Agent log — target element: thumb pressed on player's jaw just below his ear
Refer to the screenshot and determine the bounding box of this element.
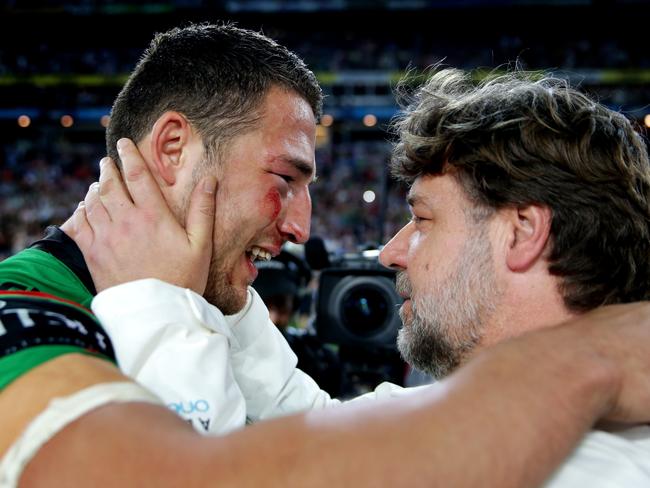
[185,175,217,252]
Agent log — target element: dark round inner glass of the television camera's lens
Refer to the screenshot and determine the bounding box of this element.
[341,285,389,336]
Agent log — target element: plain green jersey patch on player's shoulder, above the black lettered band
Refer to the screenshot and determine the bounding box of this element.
[0,249,93,309]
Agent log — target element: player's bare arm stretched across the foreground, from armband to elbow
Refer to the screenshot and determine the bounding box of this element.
[20,320,615,487]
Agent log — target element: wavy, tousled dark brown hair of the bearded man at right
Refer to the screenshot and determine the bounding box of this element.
[392,69,650,311]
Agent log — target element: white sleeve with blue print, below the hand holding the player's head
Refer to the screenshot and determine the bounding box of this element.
[92,279,246,434]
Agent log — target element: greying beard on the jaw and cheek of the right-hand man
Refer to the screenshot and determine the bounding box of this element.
[397,226,500,379]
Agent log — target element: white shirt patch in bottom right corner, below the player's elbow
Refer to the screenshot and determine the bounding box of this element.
[544,426,650,488]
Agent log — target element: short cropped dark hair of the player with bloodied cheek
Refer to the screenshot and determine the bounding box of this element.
[106,23,322,162]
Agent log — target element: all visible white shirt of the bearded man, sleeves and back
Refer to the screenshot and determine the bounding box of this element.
[92,279,650,488]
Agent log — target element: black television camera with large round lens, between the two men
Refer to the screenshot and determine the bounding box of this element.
[305,241,407,397]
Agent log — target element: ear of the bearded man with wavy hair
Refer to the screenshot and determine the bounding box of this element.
[506,205,553,272]
